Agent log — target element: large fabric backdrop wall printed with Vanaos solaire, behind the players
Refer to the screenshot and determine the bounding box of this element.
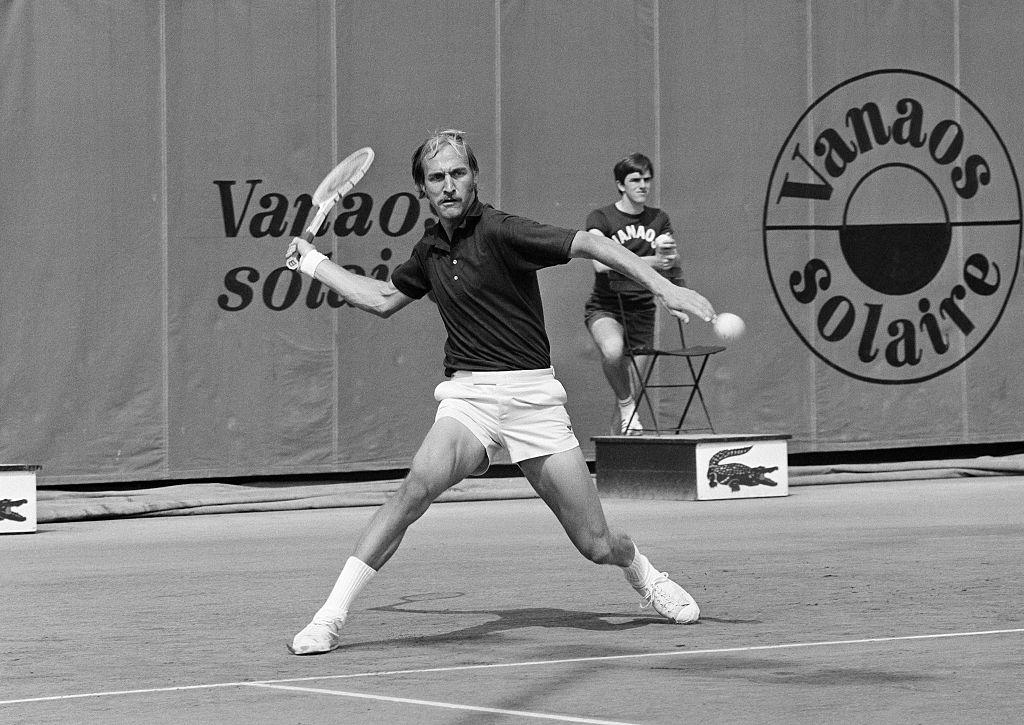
[0,0,1024,483]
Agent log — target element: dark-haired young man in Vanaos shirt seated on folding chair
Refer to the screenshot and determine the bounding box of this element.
[584,154,679,434]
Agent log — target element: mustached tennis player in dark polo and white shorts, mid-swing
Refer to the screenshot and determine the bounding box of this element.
[289,130,714,654]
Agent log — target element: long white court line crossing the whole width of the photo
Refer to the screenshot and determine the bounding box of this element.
[0,628,1024,705]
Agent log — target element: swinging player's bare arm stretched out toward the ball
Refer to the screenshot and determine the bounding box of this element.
[569,231,715,322]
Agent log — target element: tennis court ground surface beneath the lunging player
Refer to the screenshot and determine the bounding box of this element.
[0,476,1024,725]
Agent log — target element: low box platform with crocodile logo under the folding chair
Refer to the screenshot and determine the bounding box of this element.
[592,433,791,501]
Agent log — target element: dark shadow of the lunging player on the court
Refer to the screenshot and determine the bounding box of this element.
[345,592,671,649]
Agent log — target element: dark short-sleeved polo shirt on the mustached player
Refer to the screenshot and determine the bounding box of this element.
[391,200,575,376]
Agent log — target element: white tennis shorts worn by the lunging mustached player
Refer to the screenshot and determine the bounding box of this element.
[434,368,580,475]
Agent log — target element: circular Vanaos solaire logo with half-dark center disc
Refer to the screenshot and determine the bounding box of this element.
[764,70,1021,384]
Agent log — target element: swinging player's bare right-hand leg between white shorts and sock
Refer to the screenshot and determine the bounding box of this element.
[519,447,636,567]
